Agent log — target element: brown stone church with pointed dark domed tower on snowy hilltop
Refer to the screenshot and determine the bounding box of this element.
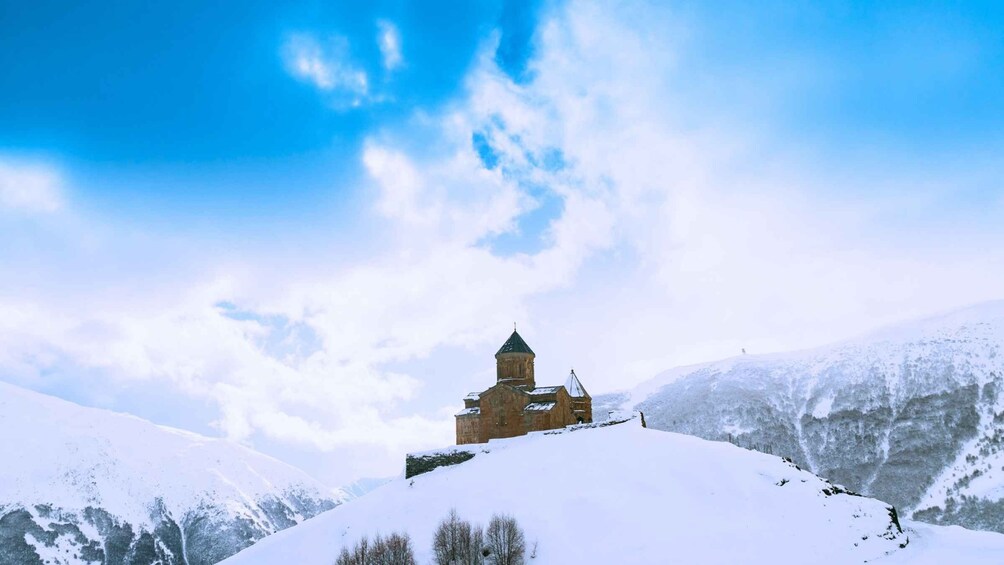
[457,330,592,445]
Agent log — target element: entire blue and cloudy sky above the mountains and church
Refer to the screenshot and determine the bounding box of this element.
[0,0,1004,486]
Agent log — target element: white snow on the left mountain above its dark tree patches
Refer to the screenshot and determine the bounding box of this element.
[0,382,337,525]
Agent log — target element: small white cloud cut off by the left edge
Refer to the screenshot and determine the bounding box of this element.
[0,158,64,214]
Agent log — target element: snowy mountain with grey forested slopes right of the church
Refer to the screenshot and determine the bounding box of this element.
[593,302,1004,532]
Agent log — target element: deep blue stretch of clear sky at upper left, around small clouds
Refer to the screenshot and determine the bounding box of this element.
[0,2,537,229]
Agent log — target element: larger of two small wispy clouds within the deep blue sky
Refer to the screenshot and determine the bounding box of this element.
[285,34,369,105]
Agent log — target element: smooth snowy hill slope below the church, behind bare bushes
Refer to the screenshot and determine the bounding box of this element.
[225,419,927,565]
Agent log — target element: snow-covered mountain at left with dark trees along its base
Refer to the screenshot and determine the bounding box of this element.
[0,382,339,565]
